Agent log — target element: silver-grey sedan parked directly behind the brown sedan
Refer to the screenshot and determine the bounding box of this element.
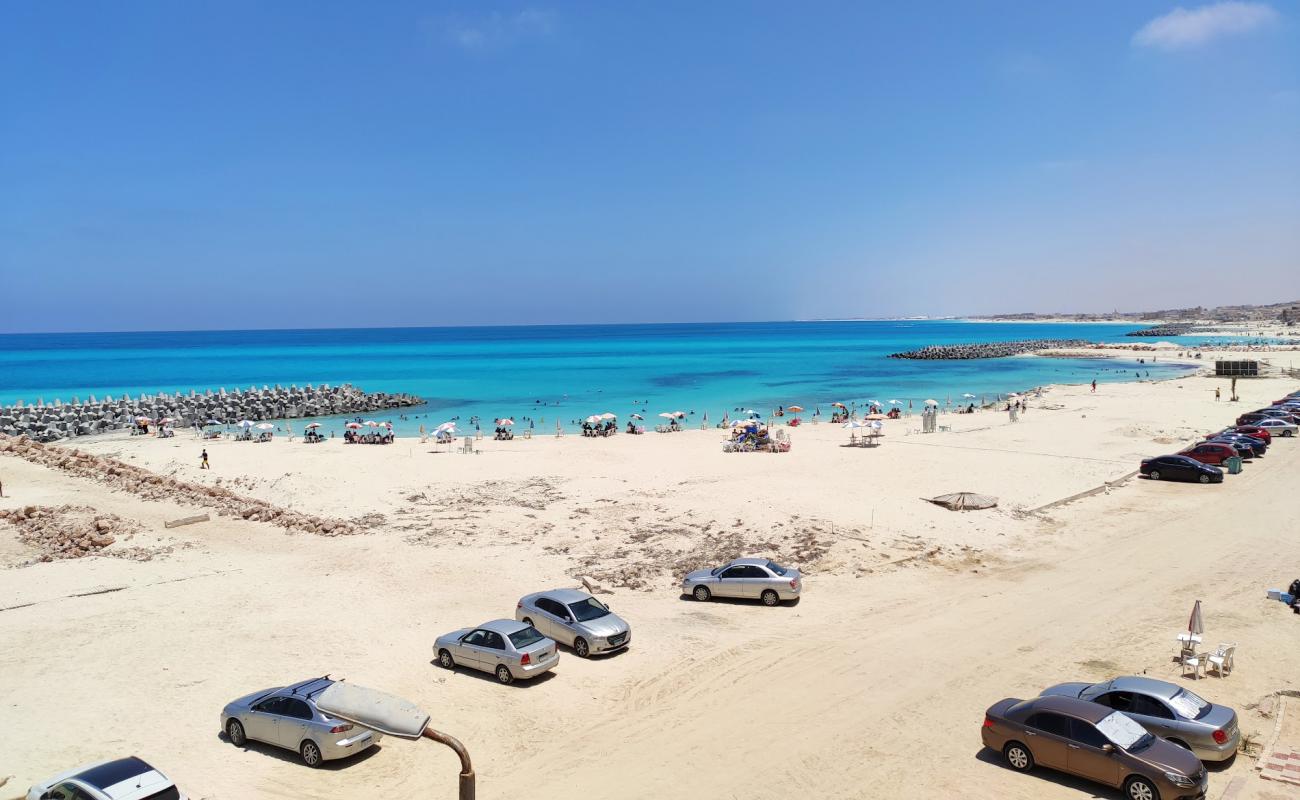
[1043,675,1242,761]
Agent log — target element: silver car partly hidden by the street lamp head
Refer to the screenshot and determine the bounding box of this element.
[221,675,384,767]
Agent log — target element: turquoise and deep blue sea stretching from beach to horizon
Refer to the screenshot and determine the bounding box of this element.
[0,320,1191,432]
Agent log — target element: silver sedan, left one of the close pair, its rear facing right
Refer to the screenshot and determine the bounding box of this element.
[433,619,560,686]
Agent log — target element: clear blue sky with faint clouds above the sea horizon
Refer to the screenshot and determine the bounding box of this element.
[0,0,1300,332]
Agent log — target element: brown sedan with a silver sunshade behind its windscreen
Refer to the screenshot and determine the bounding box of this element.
[980,696,1206,800]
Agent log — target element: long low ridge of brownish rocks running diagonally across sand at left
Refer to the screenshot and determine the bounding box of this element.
[0,436,382,536]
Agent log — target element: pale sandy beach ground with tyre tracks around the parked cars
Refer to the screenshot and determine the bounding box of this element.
[0,359,1300,799]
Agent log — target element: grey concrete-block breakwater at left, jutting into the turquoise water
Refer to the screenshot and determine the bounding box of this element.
[0,384,424,442]
